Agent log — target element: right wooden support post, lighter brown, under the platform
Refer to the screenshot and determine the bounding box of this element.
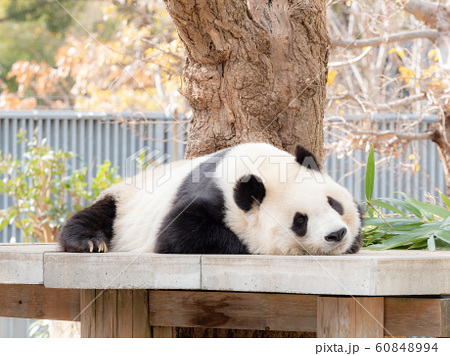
[317,297,384,337]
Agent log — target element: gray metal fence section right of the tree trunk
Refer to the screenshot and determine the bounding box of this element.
[324,114,446,201]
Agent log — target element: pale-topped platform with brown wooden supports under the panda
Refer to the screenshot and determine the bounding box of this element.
[0,244,450,337]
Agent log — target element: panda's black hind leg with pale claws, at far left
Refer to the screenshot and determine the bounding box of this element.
[58,195,116,252]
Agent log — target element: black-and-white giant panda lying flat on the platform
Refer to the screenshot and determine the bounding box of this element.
[59,143,361,255]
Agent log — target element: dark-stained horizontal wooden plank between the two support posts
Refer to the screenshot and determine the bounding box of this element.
[149,291,317,331]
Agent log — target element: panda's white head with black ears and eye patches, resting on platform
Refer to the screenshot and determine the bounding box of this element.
[226,146,362,255]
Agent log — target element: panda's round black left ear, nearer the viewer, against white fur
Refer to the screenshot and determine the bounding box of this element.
[233,174,266,211]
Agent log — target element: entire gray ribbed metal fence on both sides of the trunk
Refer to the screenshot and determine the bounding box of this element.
[0,111,445,242]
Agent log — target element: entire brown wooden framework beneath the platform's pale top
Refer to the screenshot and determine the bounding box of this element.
[0,284,450,337]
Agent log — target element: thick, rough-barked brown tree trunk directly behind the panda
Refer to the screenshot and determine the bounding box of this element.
[165,0,330,162]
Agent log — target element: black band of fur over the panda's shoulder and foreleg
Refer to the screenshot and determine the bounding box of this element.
[155,150,249,254]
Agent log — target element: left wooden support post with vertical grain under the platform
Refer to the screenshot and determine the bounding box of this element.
[80,289,151,338]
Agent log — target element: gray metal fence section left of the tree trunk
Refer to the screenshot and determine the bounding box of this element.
[0,111,187,242]
